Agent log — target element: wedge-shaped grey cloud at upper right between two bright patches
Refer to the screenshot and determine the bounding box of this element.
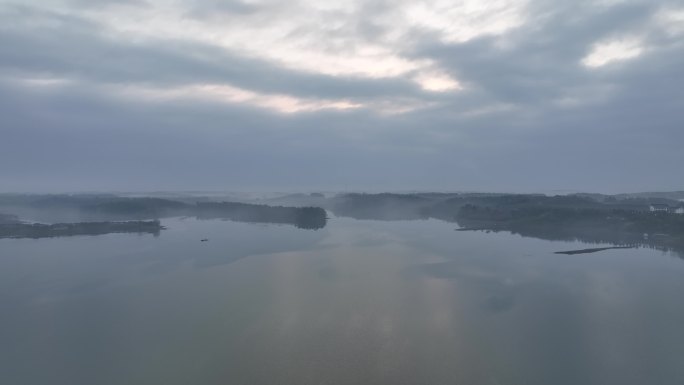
[415,3,668,105]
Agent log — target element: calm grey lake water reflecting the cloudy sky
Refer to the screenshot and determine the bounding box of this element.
[0,218,684,385]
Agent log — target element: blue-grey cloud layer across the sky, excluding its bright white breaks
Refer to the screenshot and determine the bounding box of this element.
[0,1,684,192]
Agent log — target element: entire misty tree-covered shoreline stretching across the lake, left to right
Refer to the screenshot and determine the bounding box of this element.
[0,193,684,249]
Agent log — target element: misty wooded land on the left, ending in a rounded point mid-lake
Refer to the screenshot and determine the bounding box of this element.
[0,194,328,234]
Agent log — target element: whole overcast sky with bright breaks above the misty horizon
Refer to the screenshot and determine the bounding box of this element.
[0,0,684,193]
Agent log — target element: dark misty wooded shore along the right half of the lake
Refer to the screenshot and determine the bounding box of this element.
[333,194,684,254]
